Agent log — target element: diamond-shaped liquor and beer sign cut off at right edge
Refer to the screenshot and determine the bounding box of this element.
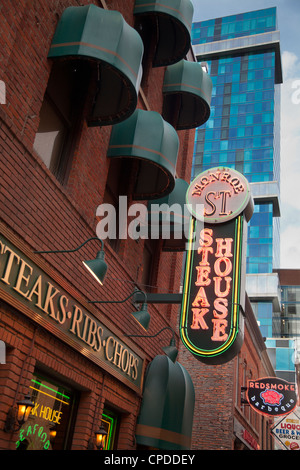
[271,410,300,450]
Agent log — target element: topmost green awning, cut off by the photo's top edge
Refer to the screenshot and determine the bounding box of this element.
[133,0,194,67]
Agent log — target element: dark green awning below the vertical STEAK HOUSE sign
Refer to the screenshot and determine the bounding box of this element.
[136,356,195,450]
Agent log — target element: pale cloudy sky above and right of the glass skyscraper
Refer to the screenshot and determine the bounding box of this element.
[191,0,300,269]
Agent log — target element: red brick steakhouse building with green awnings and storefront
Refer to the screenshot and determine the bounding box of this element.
[0,0,276,450]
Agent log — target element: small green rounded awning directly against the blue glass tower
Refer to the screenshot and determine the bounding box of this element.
[162,60,212,129]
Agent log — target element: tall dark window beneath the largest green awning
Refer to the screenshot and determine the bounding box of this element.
[33,61,89,184]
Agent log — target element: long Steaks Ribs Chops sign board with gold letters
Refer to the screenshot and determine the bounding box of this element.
[0,227,144,392]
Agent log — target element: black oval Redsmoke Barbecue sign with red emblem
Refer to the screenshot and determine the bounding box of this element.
[246,377,297,416]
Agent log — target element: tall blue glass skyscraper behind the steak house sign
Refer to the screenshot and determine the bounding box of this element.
[192,8,282,337]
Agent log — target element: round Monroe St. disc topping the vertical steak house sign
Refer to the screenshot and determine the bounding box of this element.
[186,167,254,224]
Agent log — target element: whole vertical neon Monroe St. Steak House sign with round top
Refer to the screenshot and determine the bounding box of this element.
[180,167,253,364]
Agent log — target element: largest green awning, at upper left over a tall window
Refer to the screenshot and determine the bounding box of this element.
[48,5,144,126]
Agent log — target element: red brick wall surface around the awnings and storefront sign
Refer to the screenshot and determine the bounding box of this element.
[0,0,194,449]
